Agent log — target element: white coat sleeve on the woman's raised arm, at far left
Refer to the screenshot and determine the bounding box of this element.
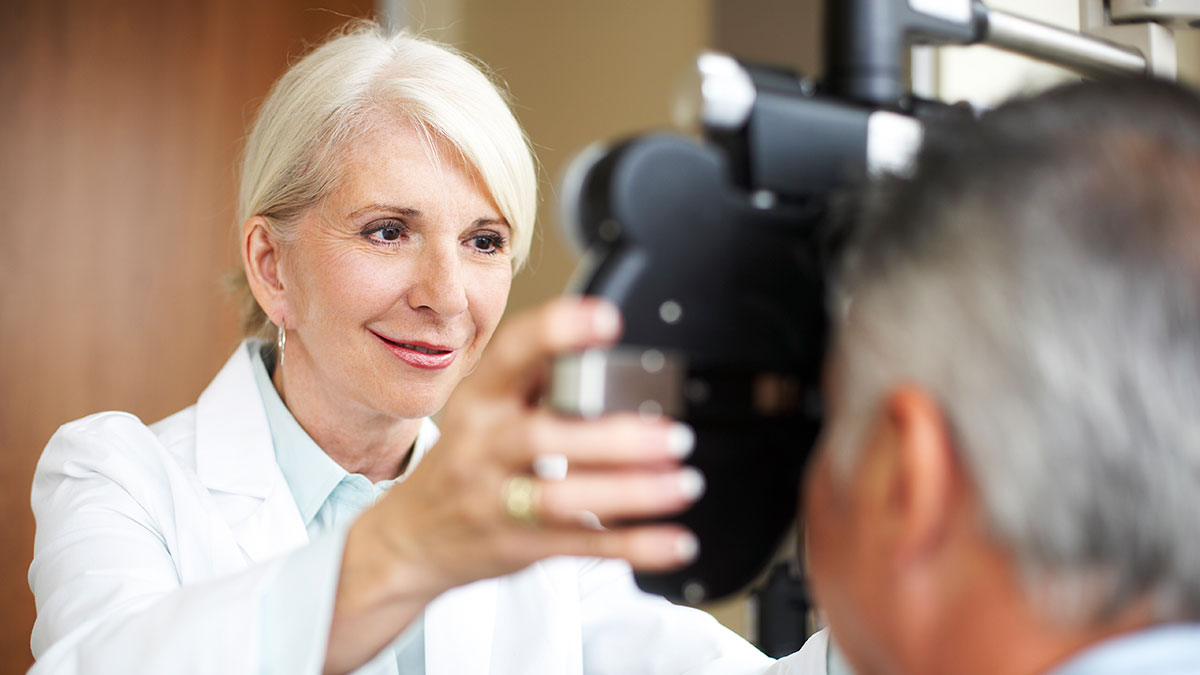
[29,413,344,675]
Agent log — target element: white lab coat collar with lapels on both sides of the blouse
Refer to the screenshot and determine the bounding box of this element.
[188,340,498,674]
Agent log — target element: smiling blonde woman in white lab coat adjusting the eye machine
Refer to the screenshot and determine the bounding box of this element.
[30,24,816,674]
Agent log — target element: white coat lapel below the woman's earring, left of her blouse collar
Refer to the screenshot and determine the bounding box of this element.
[189,340,308,561]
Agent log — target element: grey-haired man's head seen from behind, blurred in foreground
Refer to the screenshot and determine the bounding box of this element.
[805,80,1200,673]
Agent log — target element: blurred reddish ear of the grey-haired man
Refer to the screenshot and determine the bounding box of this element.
[884,386,965,563]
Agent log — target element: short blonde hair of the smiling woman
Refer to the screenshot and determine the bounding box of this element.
[235,20,538,335]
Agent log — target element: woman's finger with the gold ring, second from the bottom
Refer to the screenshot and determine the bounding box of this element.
[534,466,704,524]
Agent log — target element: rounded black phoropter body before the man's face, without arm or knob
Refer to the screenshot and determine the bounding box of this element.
[564,135,826,601]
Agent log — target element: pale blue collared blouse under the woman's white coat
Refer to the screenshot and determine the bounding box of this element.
[251,345,425,675]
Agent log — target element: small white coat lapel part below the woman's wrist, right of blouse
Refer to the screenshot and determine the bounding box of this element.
[425,579,499,675]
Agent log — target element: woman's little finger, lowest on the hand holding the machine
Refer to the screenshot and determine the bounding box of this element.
[524,525,700,572]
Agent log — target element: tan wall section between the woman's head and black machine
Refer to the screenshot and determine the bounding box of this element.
[455,0,710,316]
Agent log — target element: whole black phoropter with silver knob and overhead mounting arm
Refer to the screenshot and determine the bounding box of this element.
[550,0,1152,603]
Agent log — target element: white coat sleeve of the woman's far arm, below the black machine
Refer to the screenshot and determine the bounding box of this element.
[580,561,773,675]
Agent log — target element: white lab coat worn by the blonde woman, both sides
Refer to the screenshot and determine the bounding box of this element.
[29,345,823,675]
